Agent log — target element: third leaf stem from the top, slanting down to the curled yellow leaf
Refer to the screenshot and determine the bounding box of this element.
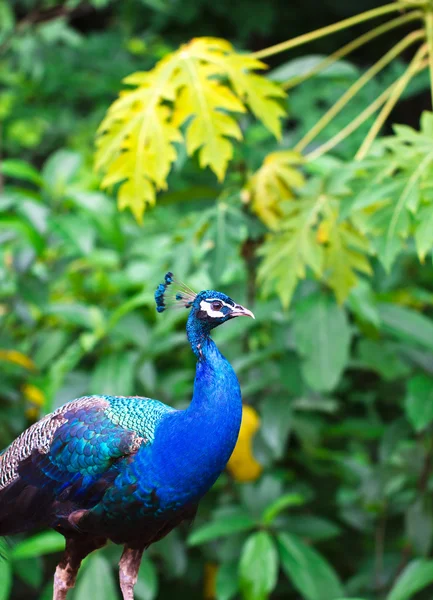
[294,30,424,152]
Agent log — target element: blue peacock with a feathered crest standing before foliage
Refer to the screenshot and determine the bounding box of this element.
[0,273,254,600]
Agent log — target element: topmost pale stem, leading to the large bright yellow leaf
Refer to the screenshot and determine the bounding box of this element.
[252,2,414,59]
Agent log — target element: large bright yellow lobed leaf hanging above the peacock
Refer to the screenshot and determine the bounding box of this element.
[96,38,285,220]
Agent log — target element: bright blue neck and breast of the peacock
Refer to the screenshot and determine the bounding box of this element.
[104,340,242,516]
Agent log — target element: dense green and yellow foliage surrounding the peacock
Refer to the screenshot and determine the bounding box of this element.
[4,0,433,600]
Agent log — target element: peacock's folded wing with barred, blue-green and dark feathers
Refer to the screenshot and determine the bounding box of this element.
[0,396,148,535]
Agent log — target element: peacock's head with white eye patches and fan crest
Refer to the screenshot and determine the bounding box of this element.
[155,273,255,331]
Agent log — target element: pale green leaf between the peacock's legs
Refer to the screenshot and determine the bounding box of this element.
[74,552,119,600]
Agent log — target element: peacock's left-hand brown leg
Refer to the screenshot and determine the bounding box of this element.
[53,538,107,600]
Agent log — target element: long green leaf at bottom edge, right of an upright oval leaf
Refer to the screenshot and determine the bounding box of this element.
[277,533,343,600]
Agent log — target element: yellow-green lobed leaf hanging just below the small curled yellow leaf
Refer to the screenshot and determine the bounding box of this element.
[259,190,371,307]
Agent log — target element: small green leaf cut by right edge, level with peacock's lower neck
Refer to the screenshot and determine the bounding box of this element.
[405,374,433,431]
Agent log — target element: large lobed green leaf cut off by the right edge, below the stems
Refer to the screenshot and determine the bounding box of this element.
[345,113,433,271]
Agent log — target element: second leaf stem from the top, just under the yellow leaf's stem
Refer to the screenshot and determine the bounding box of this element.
[282,10,423,90]
